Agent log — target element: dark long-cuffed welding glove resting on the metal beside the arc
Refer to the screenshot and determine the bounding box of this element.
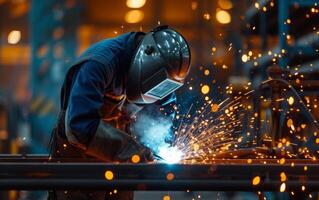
[86,120,153,162]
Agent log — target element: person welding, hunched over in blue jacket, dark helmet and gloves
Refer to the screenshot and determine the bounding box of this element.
[49,26,190,200]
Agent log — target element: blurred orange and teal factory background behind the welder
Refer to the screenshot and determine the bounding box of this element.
[0,0,319,199]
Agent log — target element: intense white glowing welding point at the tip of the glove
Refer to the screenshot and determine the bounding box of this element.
[158,147,183,164]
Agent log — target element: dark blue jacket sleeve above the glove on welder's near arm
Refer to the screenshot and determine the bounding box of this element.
[66,61,113,145]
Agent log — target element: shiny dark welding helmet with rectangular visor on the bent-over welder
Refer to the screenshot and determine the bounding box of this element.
[126,26,191,104]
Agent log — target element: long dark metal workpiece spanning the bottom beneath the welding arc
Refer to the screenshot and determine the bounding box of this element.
[0,156,319,191]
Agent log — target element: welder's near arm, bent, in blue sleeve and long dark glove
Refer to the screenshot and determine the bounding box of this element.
[65,61,151,161]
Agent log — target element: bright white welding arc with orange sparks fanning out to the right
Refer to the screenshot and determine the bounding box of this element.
[158,78,319,166]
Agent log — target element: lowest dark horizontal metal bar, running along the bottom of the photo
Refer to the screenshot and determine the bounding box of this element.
[0,179,319,192]
